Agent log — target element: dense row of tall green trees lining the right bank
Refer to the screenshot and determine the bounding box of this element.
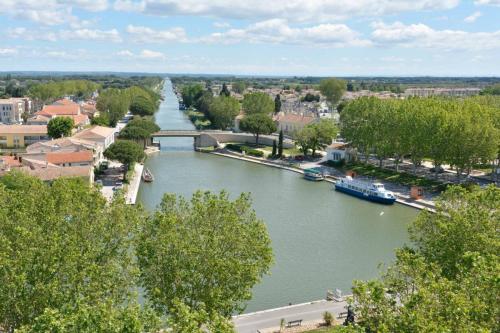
[341,97,500,175]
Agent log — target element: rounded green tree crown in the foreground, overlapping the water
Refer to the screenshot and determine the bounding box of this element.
[137,191,273,318]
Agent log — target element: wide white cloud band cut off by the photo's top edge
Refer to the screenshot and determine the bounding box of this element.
[115,0,460,22]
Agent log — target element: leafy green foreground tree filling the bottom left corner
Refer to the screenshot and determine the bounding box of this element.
[0,172,142,332]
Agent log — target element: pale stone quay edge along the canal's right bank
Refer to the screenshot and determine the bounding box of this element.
[207,150,436,212]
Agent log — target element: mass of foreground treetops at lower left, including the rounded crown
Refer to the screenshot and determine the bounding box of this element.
[0,172,273,333]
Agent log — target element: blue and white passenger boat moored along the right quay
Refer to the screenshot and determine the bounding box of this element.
[335,176,396,205]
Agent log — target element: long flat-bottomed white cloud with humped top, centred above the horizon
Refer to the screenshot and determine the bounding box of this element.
[200,19,370,47]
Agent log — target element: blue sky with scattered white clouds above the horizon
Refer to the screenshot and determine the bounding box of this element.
[0,0,500,76]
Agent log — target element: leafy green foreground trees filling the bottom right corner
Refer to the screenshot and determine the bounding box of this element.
[352,185,500,333]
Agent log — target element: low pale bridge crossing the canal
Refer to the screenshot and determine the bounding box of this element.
[151,130,294,148]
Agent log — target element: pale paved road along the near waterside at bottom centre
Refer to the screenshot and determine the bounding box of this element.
[233,300,347,333]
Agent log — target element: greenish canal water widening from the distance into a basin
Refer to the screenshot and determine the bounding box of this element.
[138,80,418,312]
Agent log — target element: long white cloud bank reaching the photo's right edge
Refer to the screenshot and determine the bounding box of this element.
[372,22,500,50]
